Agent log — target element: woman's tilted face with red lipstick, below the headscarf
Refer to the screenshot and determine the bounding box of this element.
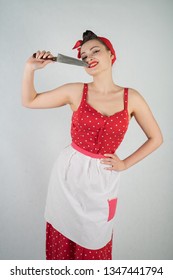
[80,39,113,75]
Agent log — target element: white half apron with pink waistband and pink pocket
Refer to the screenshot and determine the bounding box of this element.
[45,144,120,254]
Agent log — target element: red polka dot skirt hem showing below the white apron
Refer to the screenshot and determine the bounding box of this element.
[46,223,112,260]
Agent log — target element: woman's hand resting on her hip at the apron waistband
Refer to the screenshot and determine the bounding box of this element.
[100,154,126,171]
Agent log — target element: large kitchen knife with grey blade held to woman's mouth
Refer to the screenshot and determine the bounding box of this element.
[33,53,88,67]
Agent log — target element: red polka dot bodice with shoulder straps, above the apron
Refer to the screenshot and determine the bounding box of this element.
[71,84,129,155]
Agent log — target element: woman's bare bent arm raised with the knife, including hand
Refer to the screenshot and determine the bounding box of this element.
[22,51,81,109]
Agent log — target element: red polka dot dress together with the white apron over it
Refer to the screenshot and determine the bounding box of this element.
[45,84,129,260]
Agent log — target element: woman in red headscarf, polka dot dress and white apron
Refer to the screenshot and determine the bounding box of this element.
[22,31,162,260]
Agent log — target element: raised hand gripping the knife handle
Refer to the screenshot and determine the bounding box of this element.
[26,51,53,70]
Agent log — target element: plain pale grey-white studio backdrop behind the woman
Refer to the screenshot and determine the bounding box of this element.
[0,0,173,260]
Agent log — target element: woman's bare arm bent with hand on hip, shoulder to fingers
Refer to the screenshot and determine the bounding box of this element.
[102,90,163,171]
